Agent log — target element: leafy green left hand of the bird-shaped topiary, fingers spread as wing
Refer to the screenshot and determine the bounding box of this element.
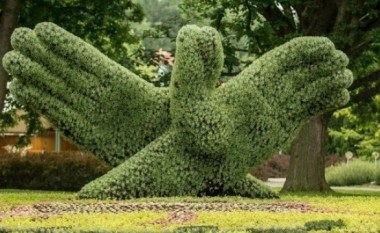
[3,23,169,166]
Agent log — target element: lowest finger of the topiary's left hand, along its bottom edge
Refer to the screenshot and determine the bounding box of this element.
[10,77,125,165]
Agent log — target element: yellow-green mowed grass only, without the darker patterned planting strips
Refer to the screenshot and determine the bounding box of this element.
[0,190,380,232]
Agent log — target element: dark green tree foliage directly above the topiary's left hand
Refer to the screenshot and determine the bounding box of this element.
[19,0,144,68]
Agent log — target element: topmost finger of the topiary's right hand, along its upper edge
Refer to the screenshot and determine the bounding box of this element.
[232,37,348,87]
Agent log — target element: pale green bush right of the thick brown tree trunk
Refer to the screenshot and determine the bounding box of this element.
[326,159,375,186]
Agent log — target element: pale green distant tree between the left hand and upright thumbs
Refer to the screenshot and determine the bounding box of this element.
[130,0,183,86]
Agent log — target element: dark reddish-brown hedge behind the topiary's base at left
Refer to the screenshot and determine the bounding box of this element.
[0,152,110,191]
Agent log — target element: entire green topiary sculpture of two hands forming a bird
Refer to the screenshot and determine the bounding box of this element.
[3,23,352,199]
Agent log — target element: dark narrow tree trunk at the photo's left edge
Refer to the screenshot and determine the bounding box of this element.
[0,0,20,115]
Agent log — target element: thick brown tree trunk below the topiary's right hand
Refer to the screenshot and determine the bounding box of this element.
[282,113,331,192]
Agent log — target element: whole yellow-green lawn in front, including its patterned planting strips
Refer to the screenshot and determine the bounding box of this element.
[0,190,380,232]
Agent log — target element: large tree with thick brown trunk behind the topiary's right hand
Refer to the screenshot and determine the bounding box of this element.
[181,0,380,191]
